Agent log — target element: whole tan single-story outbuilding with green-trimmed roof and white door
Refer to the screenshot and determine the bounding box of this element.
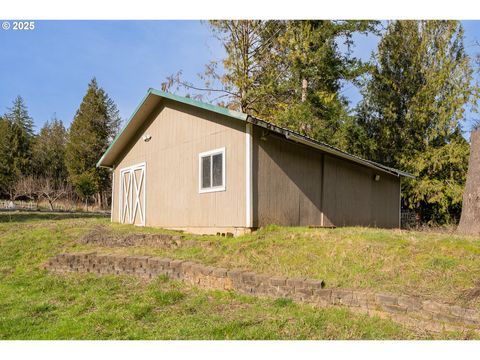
[97,89,410,235]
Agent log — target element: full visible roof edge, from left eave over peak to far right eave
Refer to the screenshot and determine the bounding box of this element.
[97,88,414,178]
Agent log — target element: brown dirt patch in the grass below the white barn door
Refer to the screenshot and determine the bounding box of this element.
[78,226,212,249]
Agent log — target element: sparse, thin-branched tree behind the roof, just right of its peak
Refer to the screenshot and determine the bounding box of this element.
[162,20,280,114]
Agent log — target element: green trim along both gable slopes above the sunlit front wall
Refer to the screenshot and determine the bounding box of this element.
[96,88,248,167]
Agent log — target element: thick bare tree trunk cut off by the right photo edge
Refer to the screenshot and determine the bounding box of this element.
[457,130,480,235]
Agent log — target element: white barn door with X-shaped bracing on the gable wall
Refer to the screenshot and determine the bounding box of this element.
[118,163,146,226]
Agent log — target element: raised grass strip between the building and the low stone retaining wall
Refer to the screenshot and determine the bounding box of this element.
[78,219,480,310]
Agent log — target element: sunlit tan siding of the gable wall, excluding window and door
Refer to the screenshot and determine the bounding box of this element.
[113,100,246,228]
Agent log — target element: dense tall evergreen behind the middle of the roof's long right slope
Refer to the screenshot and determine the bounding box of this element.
[255,20,377,147]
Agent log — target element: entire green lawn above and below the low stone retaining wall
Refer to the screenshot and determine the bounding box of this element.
[0,214,480,339]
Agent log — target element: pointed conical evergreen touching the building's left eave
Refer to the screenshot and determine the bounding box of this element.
[65,78,120,206]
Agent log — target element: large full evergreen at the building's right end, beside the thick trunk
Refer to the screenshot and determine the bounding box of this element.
[352,21,476,223]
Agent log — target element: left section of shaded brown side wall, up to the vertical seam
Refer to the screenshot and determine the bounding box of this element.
[253,126,323,227]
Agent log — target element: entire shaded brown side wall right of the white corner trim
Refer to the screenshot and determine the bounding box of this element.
[253,127,400,228]
